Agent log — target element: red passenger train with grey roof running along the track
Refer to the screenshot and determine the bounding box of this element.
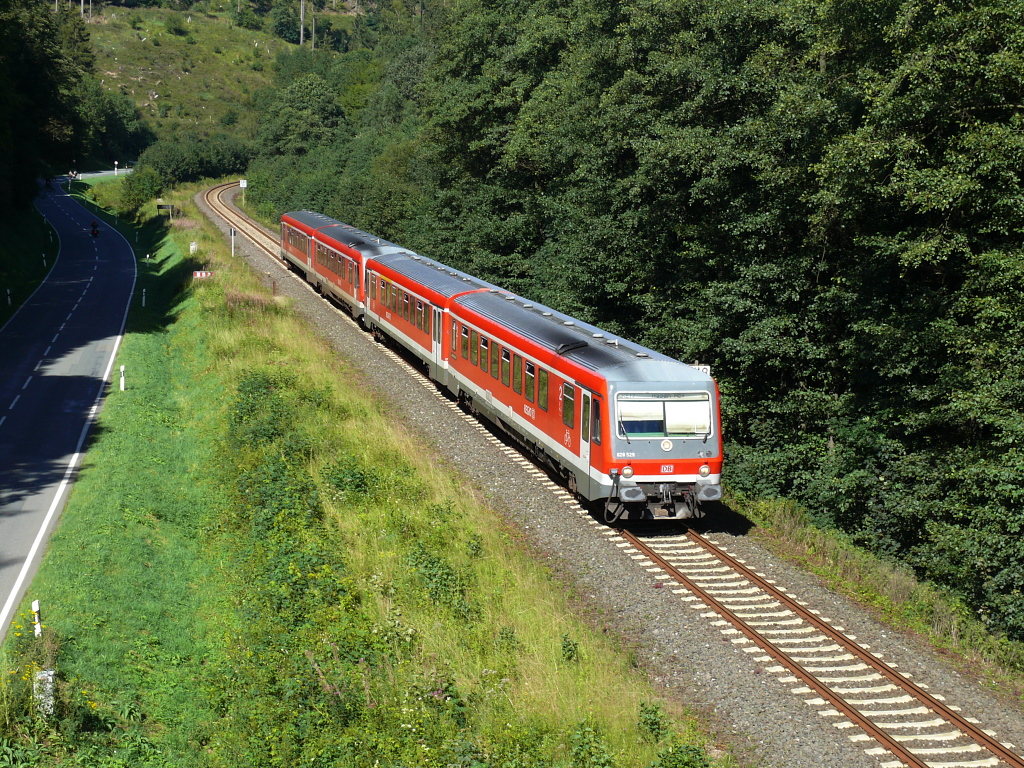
[281,211,722,522]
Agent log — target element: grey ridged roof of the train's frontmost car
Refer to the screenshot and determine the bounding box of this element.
[455,290,712,385]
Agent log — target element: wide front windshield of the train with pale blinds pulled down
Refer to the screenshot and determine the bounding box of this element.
[615,392,711,439]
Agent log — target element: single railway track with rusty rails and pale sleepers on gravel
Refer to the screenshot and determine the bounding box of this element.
[204,182,1024,768]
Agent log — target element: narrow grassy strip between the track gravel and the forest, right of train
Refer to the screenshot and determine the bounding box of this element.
[730,499,1024,701]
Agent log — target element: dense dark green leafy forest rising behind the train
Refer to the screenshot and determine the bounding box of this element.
[0,0,1024,639]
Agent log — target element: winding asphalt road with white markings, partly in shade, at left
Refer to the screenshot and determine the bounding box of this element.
[0,180,135,641]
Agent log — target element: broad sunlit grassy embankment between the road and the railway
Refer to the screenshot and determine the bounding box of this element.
[0,177,730,768]
